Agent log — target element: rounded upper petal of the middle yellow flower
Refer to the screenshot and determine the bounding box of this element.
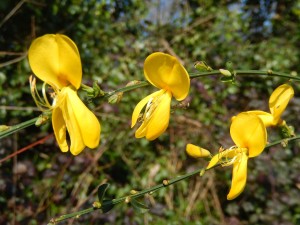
[144,52,190,101]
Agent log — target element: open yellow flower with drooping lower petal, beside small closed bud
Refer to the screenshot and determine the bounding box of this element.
[207,112,267,200]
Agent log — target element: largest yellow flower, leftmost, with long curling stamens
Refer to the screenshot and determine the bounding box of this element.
[28,34,101,155]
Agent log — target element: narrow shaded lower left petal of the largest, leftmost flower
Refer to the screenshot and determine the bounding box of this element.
[52,107,69,152]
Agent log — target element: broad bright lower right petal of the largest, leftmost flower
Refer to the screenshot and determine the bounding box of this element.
[64,87,101,155]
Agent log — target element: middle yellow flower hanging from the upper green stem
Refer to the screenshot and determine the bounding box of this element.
[131,52,190,141]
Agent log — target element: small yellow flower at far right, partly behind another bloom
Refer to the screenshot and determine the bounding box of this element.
[248,84,294,127]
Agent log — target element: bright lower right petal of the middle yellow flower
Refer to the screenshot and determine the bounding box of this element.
[135,92,172,141]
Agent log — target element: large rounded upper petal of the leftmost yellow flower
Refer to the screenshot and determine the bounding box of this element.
[28,34,82,89]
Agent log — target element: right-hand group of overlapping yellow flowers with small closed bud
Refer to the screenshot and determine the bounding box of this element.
[186,84,294,200]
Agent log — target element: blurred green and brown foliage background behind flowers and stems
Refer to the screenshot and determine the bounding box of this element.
[0,0,300,225]
